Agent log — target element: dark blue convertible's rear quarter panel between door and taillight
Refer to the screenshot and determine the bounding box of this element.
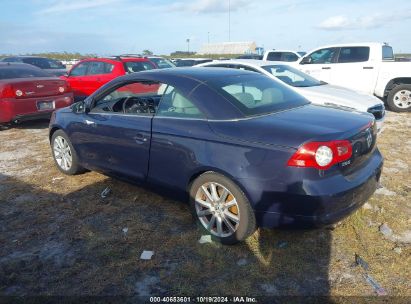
[149,117,295,204]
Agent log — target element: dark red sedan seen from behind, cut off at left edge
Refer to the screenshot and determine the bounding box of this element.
[0,63,73,124]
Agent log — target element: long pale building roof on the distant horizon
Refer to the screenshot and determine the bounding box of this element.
[197,42,257,55]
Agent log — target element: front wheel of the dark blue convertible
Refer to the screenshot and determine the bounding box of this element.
[51,130,85,175]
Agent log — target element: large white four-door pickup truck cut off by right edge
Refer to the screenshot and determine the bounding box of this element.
[289,43,411,112]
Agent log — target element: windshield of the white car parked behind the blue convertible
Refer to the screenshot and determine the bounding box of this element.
[262,65,326,87]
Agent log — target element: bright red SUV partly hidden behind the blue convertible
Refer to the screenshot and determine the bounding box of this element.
[61,57,157,101]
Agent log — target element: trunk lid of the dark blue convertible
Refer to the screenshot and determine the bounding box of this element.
[209,104,374,148]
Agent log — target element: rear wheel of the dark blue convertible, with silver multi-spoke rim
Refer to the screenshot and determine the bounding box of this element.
[190,171,256,245]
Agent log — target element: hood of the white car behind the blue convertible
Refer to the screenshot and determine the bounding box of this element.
[295,84,383,112]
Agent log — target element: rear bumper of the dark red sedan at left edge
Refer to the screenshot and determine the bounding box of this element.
[0,93,73,123]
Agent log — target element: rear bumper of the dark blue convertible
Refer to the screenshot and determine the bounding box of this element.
[240,149,383,228]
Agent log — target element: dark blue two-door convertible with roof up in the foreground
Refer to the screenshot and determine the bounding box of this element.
[50,68,383,244]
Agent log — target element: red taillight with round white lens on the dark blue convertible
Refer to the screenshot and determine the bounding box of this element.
[287,140,352,170]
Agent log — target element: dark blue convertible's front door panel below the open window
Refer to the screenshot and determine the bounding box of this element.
[76,113,152,180]
